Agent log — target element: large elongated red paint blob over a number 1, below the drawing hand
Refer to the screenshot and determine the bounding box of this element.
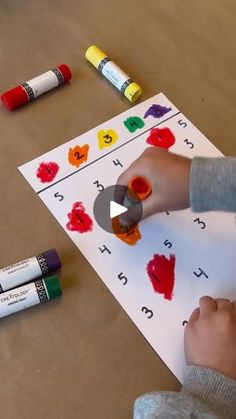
[147,255,175,300]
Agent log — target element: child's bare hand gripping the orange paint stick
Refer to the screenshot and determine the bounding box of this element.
[117,147,191,218]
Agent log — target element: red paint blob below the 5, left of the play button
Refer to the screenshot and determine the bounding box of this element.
[66,202,93,233]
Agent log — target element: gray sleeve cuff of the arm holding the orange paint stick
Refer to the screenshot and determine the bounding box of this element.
[190,157,236,212]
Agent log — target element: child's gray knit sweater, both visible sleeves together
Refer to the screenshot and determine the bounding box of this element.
[134,157,236,419]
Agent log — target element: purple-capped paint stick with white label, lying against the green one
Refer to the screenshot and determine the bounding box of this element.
[0,249,61,293]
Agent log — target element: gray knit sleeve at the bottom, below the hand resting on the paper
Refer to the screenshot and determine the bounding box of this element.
[133,366,236,419]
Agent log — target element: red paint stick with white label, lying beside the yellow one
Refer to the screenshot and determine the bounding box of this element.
[1,64,72,111]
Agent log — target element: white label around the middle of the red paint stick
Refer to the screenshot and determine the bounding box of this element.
[26,70,59,98]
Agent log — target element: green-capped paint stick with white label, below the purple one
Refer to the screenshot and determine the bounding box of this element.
[0,276,62,318]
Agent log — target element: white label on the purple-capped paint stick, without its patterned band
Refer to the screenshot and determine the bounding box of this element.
[0,257,42,295]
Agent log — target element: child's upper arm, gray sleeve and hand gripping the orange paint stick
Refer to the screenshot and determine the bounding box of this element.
[117,147,236,218]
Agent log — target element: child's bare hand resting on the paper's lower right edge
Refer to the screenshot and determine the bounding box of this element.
[185,297,236,380]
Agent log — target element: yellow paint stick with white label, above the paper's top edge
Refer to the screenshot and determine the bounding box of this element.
[85,45,142,103]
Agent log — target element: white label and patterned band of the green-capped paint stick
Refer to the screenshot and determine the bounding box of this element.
[0,280,48,318]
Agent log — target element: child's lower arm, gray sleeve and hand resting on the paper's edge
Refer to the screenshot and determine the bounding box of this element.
[134,297,236,419]
